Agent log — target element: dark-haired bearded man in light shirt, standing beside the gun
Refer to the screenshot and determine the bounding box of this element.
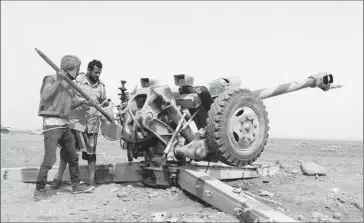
[51,60,109,189]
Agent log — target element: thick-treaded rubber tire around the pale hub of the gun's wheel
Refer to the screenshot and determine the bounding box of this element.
[206,89,269,166]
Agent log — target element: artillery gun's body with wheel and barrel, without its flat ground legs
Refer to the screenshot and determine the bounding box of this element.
[112,73,340,187]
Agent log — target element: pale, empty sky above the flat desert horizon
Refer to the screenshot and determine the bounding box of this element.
[1,1,363,141]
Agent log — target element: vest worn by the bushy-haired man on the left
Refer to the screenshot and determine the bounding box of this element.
[38,75,76,119]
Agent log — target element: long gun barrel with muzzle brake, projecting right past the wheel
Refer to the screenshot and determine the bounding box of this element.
[253,73,341,99]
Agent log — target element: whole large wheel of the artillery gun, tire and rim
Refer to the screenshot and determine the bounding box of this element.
[206,89,269,166]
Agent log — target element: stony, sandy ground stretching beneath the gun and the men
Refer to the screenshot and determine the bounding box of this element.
[1,134,363,222]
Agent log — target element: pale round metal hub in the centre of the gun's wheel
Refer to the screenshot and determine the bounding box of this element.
[230,107,259,149]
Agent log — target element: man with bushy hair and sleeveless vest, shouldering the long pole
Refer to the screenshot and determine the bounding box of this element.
[34,55,95,200]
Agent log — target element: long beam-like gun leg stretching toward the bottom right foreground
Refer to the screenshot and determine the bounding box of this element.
[178,168,297,222]
